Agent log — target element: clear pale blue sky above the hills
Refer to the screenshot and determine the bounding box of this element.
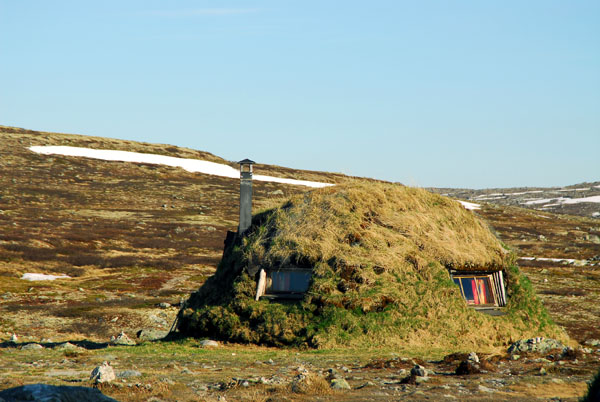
[0,0,600,188]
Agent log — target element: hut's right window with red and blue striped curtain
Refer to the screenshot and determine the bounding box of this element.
[452,271,506,306]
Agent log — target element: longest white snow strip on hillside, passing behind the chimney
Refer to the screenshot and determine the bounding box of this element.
[29,146,333,188]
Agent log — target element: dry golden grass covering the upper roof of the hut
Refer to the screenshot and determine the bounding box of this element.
[247,182,505,269]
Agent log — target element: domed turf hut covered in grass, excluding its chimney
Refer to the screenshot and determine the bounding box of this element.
[178,181,561,350]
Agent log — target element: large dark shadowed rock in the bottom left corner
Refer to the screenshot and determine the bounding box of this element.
[0,384,117,402]
